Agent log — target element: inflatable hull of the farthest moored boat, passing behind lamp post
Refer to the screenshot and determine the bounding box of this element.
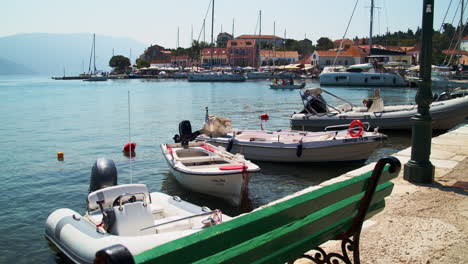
[290,96,468,130]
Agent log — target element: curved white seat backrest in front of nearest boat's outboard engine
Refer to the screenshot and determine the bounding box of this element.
[88,184,150,211]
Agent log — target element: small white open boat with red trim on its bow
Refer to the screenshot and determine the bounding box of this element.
[161,142,260,206]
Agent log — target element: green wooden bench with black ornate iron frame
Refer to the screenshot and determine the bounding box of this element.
[96,157,401,263]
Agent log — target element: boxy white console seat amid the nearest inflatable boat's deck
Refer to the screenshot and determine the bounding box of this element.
[112,202,155,236]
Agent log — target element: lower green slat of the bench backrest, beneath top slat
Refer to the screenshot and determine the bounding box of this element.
[195,183,393,263]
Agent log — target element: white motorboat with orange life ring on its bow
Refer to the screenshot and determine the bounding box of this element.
[197,116,386,162]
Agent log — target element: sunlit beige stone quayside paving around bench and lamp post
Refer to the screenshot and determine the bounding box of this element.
[296,125,468,264]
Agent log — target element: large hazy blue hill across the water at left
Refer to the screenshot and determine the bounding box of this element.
[0,33,147,76]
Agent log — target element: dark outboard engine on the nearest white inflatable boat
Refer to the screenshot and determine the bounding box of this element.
[89,158,117,193]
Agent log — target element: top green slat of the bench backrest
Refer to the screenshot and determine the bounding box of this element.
[134,165,398,263]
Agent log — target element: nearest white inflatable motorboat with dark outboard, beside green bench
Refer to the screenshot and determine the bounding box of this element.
[45,159,231,263]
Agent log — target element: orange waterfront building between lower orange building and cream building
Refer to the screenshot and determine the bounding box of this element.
[227,39,260,67]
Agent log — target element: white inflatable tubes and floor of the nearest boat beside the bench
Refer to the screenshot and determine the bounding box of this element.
[44,193,220,263]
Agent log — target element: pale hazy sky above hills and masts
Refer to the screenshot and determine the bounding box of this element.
[0,0,460,48]
